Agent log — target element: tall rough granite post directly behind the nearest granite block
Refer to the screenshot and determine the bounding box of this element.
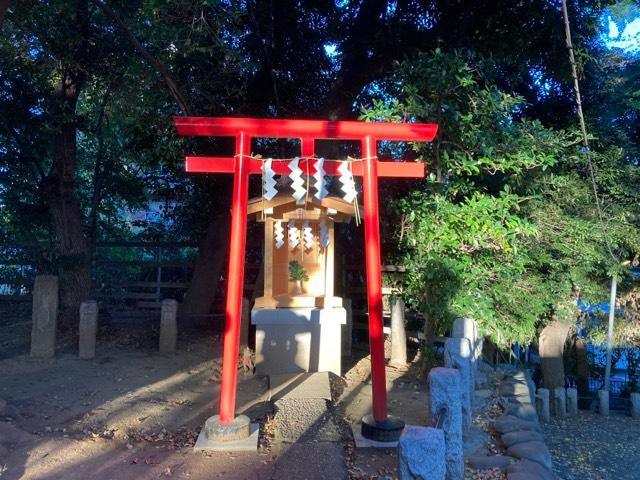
[429,367,464,480]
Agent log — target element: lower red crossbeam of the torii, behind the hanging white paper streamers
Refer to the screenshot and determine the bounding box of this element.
[186,157,425,178]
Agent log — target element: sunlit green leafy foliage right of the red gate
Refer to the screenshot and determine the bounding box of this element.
[362,49,640,345]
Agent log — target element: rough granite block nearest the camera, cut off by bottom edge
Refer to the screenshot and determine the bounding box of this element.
[398,426,446,480]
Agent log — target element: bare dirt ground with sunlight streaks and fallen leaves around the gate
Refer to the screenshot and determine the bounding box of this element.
[0,308,500,480]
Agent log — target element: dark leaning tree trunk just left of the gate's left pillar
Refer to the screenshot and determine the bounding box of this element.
[180,215,229,320]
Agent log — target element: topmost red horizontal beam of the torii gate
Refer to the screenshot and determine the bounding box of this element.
[173,117,438,142]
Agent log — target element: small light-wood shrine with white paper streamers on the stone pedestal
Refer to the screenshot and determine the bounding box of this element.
[247,194,356,308]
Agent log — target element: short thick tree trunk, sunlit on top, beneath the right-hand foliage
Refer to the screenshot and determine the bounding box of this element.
[538,320,569,390]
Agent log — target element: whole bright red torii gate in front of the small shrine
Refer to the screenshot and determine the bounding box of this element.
[174,117,438,441]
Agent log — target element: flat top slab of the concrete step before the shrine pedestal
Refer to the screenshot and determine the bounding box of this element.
[269,372,331,402]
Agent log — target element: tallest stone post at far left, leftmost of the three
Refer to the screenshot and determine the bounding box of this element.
[31,275,58,358]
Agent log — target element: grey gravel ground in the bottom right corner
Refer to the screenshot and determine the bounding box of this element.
[543,411,640,480]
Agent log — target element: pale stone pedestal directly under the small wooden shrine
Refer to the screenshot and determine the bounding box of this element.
[251,307,346,375]
